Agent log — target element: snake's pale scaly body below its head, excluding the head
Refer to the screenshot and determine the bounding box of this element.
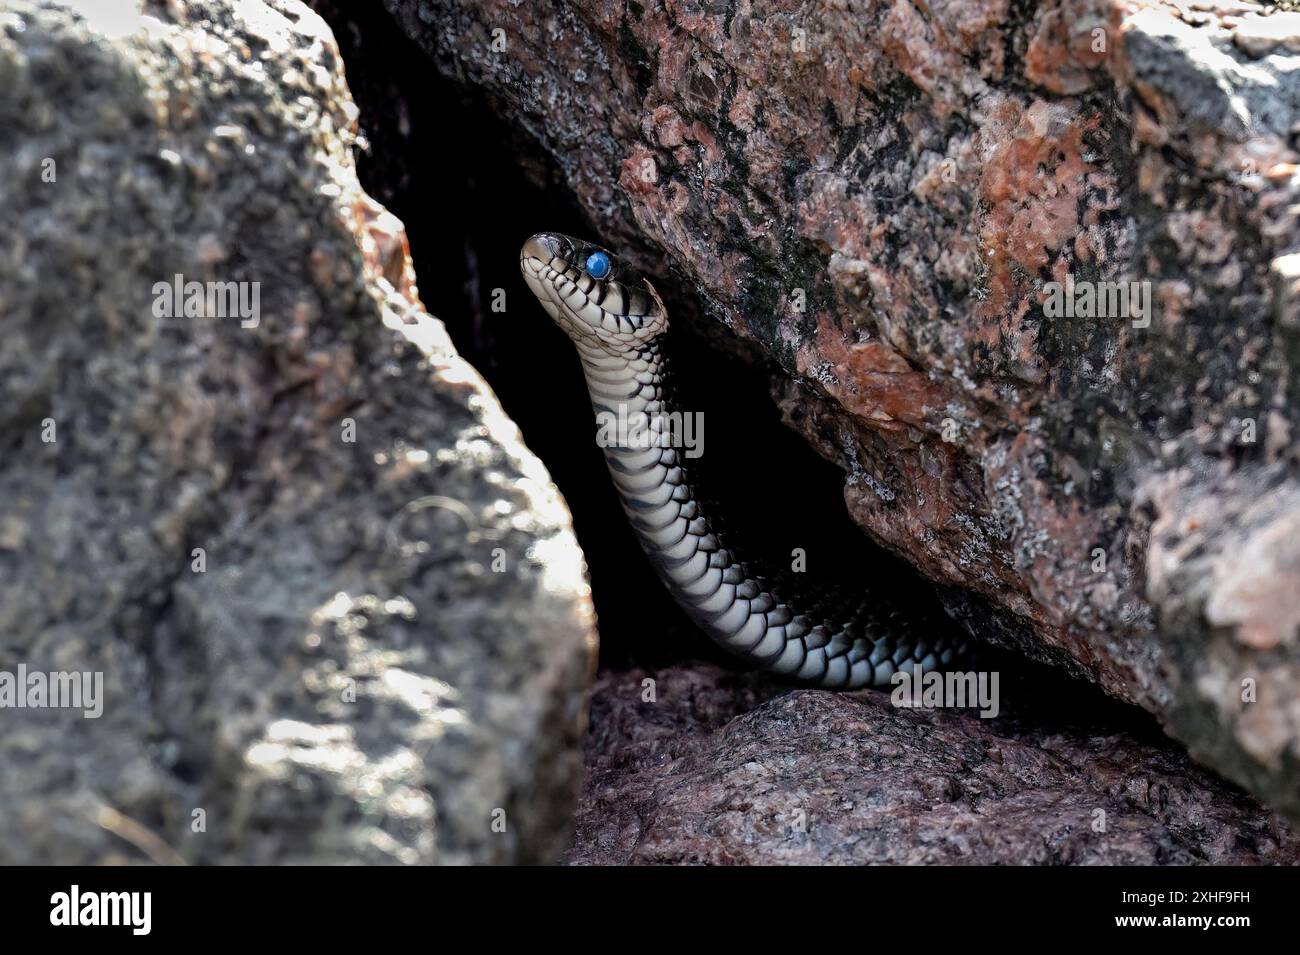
[575,339,954,689]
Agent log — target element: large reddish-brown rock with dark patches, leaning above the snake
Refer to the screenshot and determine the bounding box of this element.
[385,0,1300,816]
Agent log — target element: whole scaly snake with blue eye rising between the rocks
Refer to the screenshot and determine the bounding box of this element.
[519,233,965,690]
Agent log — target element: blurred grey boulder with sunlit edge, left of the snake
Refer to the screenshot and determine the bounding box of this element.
[0,0,594,863]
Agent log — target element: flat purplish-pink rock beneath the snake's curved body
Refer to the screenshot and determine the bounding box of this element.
[566,664,1300,865]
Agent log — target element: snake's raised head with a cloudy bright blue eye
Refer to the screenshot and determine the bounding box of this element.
[519,233,668,352]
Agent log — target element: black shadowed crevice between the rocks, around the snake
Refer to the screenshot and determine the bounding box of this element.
[312,0,1180,741]
